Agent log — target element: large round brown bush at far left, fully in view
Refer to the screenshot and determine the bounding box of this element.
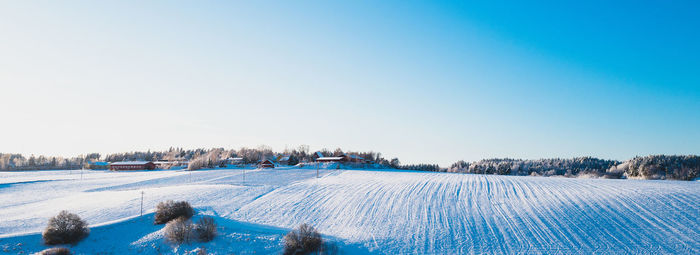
[42,211,90,245]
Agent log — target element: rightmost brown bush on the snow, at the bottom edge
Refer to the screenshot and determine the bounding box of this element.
[284,224,323,255]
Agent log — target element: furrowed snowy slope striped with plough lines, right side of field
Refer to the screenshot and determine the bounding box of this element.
[234,171,700,254]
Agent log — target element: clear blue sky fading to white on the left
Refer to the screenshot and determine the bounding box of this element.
[0,1,700,166]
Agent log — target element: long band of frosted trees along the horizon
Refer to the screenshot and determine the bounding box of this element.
[0,148,700,180]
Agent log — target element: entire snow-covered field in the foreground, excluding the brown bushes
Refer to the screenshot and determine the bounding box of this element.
[0,168,700,254]
